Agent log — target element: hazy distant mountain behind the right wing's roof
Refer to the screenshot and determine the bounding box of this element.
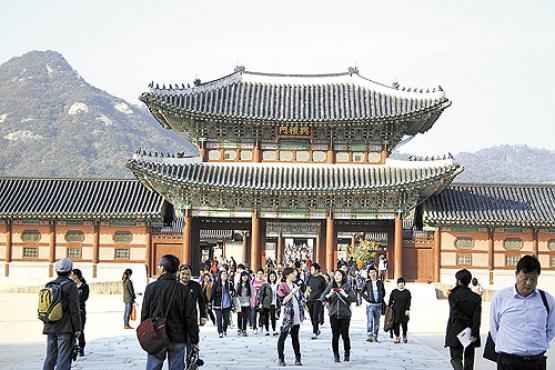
[455,145,555,183]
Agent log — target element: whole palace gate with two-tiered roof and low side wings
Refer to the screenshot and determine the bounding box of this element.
[0,67,555,287]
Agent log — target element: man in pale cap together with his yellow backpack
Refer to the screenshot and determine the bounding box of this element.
[38,258,81,370]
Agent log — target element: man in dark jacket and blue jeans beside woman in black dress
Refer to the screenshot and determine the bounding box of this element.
[362,266,385,342]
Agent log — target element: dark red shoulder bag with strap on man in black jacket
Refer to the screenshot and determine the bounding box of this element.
[137,281,179,356]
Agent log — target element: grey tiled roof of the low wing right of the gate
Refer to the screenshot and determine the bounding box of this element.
[424,184,555,227]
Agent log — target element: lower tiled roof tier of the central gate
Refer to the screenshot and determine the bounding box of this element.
[127,155,462,192]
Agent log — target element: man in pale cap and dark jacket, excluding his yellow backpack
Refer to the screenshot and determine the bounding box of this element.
[42,258,81,370]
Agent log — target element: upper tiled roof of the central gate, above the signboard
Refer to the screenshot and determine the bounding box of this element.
[140,68,450,126]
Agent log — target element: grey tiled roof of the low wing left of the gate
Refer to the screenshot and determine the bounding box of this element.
[0,178,164,219]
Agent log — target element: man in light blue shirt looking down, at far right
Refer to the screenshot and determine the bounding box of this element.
[490,256,555,370]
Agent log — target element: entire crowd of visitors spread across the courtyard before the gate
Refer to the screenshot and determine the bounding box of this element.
[39,255,555,370]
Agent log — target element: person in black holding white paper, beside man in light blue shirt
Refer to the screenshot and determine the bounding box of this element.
[445,269,482,370]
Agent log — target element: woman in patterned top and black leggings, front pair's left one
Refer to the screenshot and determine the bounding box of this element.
[277,267,304,366]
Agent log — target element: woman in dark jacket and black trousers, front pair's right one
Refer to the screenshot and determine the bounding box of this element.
[325,270,356,362]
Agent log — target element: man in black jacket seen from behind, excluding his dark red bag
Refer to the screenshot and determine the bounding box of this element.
[141,255,199,370]
